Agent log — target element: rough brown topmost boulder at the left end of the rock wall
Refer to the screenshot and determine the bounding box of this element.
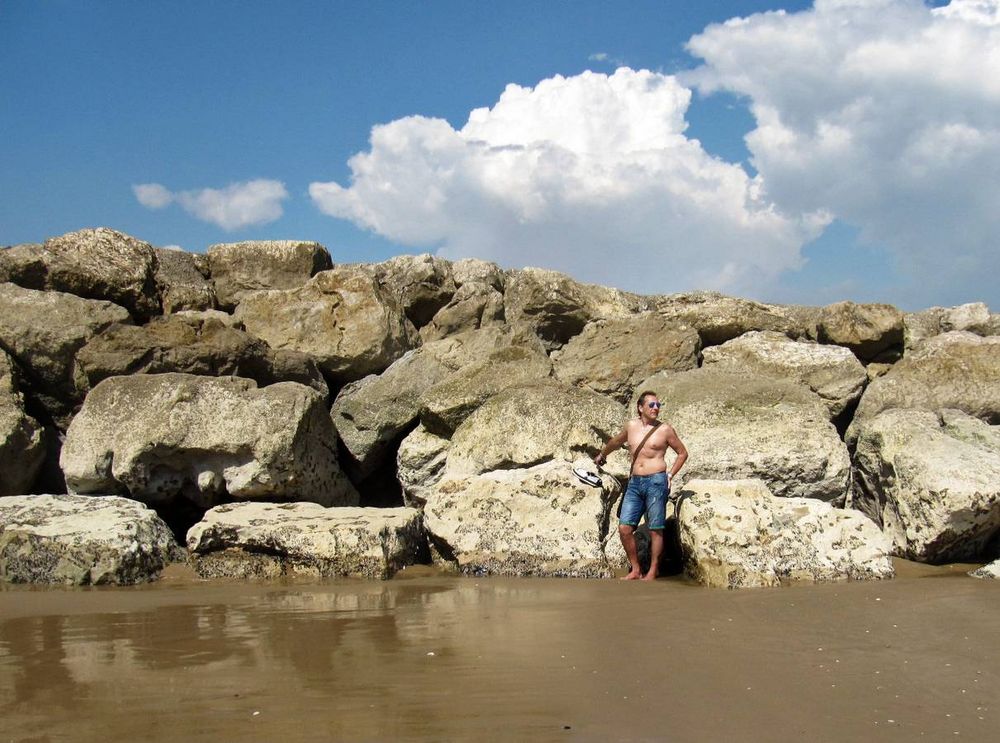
[0,227,160,318]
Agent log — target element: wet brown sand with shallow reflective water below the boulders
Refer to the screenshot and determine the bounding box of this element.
[0,562,1000,743]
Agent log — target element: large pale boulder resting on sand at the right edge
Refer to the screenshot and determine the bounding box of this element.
[854,410,1000,562]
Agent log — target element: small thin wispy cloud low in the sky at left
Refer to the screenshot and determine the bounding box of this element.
[132,179,288,231]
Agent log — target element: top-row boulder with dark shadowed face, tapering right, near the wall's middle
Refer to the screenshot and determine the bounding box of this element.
[504,268,647,350]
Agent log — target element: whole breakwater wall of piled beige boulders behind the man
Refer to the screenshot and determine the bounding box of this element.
[0,228,1000,587]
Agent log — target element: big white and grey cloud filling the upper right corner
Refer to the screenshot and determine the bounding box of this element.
[682,0,1000,302]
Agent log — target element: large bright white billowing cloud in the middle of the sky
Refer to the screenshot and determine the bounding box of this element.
[309,68,828,294]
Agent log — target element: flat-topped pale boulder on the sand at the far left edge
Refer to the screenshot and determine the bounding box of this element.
[0,495,180,585]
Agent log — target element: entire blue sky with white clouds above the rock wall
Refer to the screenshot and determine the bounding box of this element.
[0,0,1000,309]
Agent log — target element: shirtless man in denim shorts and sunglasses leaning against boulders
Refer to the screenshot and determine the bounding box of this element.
[594,391,687,580]
